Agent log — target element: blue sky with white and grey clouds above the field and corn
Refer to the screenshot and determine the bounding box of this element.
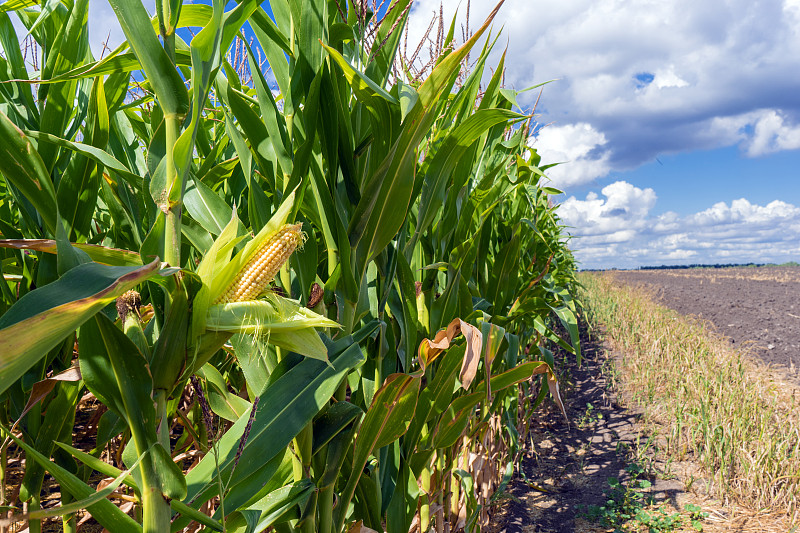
[39,0,800,268]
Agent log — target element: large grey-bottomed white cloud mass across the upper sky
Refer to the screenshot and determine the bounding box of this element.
[409,0,800,185]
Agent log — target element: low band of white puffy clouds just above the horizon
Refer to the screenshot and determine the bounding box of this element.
[558,181,800,268]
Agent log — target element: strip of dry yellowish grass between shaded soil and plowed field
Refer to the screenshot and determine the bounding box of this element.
[580,274,800,531]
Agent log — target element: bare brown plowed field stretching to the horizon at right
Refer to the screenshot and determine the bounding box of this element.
[615,267,800,381]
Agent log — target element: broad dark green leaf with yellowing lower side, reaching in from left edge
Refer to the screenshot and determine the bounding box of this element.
[0,261,159,392]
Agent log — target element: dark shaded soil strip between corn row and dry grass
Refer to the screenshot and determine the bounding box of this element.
[490,330,698,533]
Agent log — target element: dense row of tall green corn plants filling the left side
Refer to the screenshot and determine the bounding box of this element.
[0,0,580,533]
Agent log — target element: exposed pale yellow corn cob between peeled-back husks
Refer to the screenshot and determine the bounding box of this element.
[214,224,303,304]
